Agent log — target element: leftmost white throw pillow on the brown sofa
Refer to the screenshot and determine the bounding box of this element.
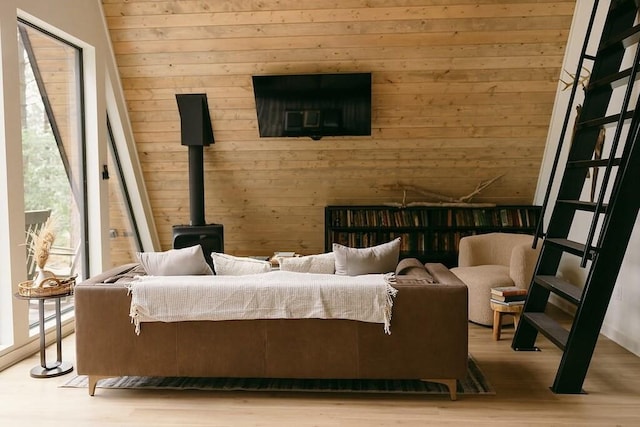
[137,245,213,276]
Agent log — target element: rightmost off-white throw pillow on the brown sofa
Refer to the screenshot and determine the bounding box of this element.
[333,237,400,276]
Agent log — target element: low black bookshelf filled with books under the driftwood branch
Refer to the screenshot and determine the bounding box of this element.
[324,205,540,267]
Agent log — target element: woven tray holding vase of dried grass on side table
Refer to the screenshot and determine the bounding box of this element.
[18,218,76,297]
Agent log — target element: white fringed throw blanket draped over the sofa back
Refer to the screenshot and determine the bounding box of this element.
[129,271,397,334]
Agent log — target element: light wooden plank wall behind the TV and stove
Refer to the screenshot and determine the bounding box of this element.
[103,0,575,255]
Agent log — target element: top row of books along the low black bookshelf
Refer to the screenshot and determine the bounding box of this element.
[329,208,538,227]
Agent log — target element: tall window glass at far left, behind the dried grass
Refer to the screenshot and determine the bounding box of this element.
[18,21,88,327]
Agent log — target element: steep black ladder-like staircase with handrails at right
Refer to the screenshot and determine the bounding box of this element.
[512,0,640,393]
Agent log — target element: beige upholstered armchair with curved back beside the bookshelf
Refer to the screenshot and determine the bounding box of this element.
[451,233,542,326]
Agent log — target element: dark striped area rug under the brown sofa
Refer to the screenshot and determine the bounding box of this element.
[61,356,495,395]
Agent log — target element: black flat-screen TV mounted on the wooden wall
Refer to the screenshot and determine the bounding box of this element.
[252,73,371,139]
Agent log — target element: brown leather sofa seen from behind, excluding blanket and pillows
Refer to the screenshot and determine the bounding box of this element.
[75,260,468,400]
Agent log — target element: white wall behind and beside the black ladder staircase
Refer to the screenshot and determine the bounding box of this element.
[535,0,640,356]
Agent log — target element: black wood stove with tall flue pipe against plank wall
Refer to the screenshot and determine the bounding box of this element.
[173,93,224,265]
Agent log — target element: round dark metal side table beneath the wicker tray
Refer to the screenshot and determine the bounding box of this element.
[14,291,73,378]
